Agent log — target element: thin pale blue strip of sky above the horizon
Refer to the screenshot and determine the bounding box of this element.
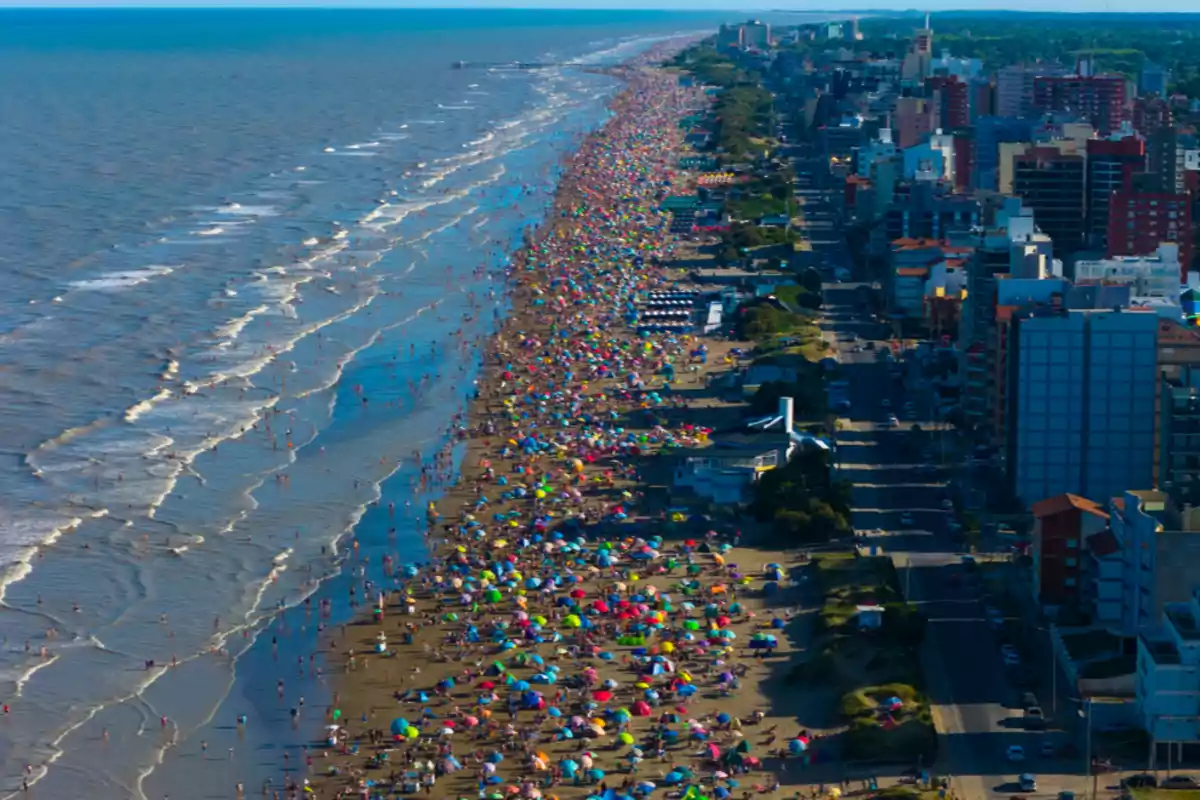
[0,0,1200,14]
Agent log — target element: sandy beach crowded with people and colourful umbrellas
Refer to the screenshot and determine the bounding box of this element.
[291,53,825,800]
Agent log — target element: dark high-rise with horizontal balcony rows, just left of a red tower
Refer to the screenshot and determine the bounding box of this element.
[1013,146,1086,253]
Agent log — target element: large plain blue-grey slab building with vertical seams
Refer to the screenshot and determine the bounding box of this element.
[1007,307,1158,503]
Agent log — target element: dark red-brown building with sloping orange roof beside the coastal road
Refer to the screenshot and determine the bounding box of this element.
[1030,493,1109,606]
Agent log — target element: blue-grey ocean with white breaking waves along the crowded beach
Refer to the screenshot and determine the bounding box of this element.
[0,10,801,800]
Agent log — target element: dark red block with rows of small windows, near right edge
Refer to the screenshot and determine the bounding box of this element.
[1104,191,1193,268]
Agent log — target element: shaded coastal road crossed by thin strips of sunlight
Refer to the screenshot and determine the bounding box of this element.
[823,284,1086,799]
